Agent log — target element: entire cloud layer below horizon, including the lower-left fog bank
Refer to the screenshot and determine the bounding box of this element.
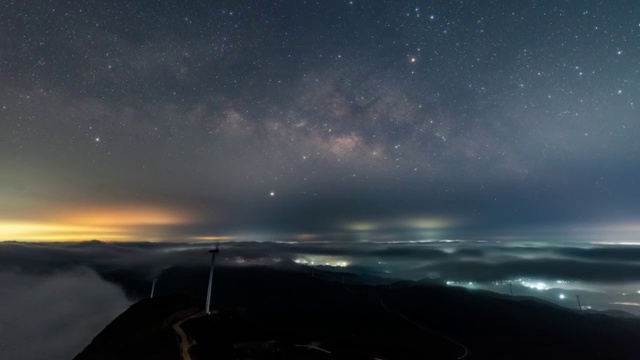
[0,238,640,360]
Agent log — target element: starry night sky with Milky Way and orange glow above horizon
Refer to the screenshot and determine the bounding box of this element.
[0,0,640,243]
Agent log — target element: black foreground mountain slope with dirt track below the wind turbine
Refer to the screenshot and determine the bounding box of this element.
[77,268,640,360]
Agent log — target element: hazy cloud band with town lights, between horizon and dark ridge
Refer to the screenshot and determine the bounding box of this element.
[0,241,640,313]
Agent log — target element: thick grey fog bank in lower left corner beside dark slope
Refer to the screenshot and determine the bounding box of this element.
[0,268,131,360]
